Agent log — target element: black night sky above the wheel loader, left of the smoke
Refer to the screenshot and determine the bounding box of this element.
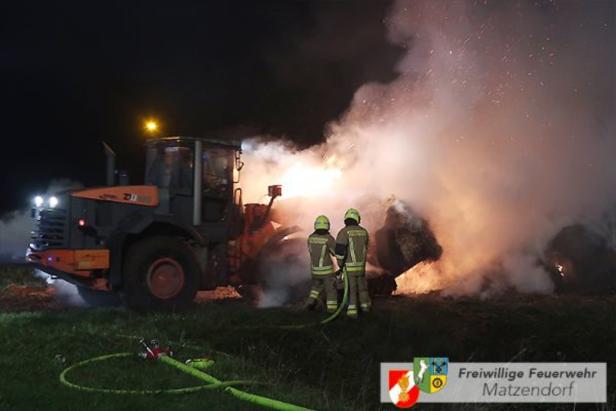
[0,1,403,213]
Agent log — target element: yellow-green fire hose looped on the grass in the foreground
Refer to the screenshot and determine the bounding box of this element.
[60,352,311,411]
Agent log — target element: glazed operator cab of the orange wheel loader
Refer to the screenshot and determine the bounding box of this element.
[145,137,241,226]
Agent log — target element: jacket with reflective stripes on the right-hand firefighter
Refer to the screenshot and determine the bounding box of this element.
[336,225,368,274]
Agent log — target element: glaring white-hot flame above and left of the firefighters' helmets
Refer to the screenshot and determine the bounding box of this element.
[281,162,342,198]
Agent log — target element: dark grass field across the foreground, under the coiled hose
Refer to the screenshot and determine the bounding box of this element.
[0,268,616,411]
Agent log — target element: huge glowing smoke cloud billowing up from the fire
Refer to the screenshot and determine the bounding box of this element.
[242,1,616,295]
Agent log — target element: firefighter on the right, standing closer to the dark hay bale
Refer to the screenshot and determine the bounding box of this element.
[335,208,372,318]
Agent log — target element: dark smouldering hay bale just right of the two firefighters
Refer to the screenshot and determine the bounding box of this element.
[375,200,443,277]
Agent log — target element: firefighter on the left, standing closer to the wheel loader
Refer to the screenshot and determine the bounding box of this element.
[305,215,338,312]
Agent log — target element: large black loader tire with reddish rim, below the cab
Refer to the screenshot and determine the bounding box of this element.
[123,236,199,309]
